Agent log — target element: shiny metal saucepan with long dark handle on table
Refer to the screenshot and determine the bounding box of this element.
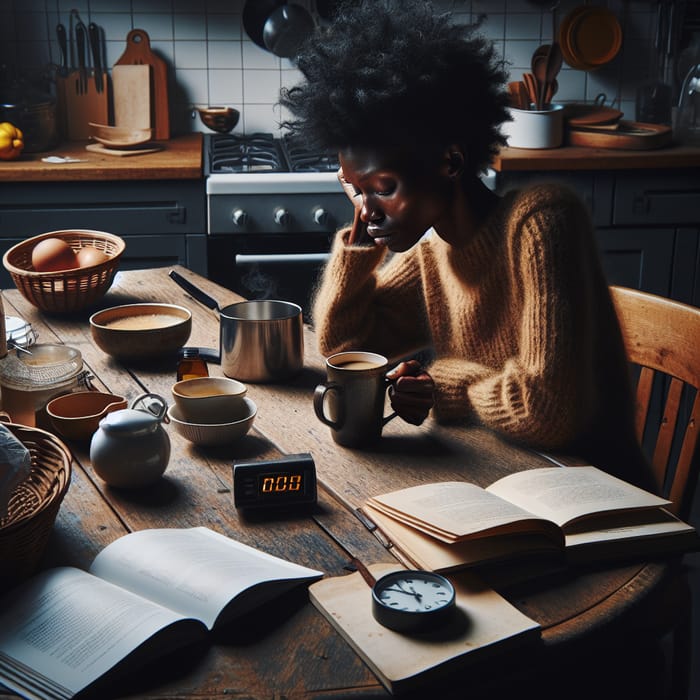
[169,270,304,383]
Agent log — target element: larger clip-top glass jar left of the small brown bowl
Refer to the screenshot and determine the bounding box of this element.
[0,344,89,428]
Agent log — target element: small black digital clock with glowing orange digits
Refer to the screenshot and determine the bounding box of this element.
[233,453,316,508]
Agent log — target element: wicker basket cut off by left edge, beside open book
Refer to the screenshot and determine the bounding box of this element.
[0,423,72,591]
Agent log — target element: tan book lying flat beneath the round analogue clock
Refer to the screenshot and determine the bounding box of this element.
[309,564,540,697]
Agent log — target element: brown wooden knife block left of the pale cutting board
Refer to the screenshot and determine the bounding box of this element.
[56,71,109,141]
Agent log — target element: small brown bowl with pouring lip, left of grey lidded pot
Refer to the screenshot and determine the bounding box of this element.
[46,391,127,440]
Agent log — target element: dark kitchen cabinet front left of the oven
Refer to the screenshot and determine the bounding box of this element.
[0,180,207,287]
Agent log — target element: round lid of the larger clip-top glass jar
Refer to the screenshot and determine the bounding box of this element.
[0,344,83,391]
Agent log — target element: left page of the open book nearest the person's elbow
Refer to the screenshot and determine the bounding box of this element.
[367,481,552,543]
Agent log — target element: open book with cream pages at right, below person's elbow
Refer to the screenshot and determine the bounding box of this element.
[362,466,700,572]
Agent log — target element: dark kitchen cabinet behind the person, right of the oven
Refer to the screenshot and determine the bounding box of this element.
[496,168,700,306]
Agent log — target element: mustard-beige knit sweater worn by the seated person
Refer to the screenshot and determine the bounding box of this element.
[313,185,653,489]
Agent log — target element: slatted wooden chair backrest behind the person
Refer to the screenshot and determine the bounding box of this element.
[610,286,700,519]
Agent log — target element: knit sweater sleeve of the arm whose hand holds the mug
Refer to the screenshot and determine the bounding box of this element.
[430,189,595,447]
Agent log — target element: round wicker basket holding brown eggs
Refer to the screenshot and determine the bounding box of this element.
[2,229,126,313]
